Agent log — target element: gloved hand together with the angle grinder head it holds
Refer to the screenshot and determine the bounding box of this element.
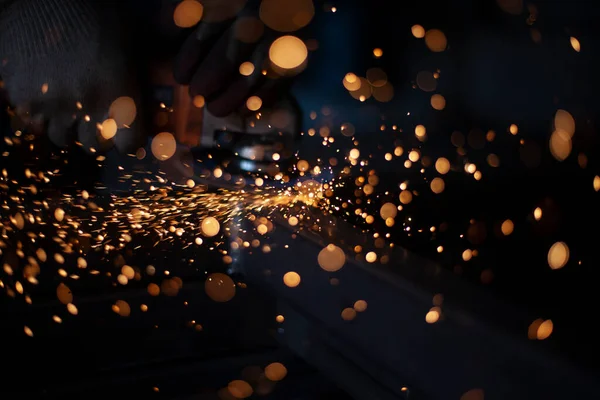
[159,0,314,180]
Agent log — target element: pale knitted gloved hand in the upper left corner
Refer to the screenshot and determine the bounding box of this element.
[0,0,140,151]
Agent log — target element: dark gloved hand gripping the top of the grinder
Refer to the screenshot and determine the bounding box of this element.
[174,0,314,117]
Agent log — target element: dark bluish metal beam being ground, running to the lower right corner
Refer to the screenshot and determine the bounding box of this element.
[231,208,600,400]
